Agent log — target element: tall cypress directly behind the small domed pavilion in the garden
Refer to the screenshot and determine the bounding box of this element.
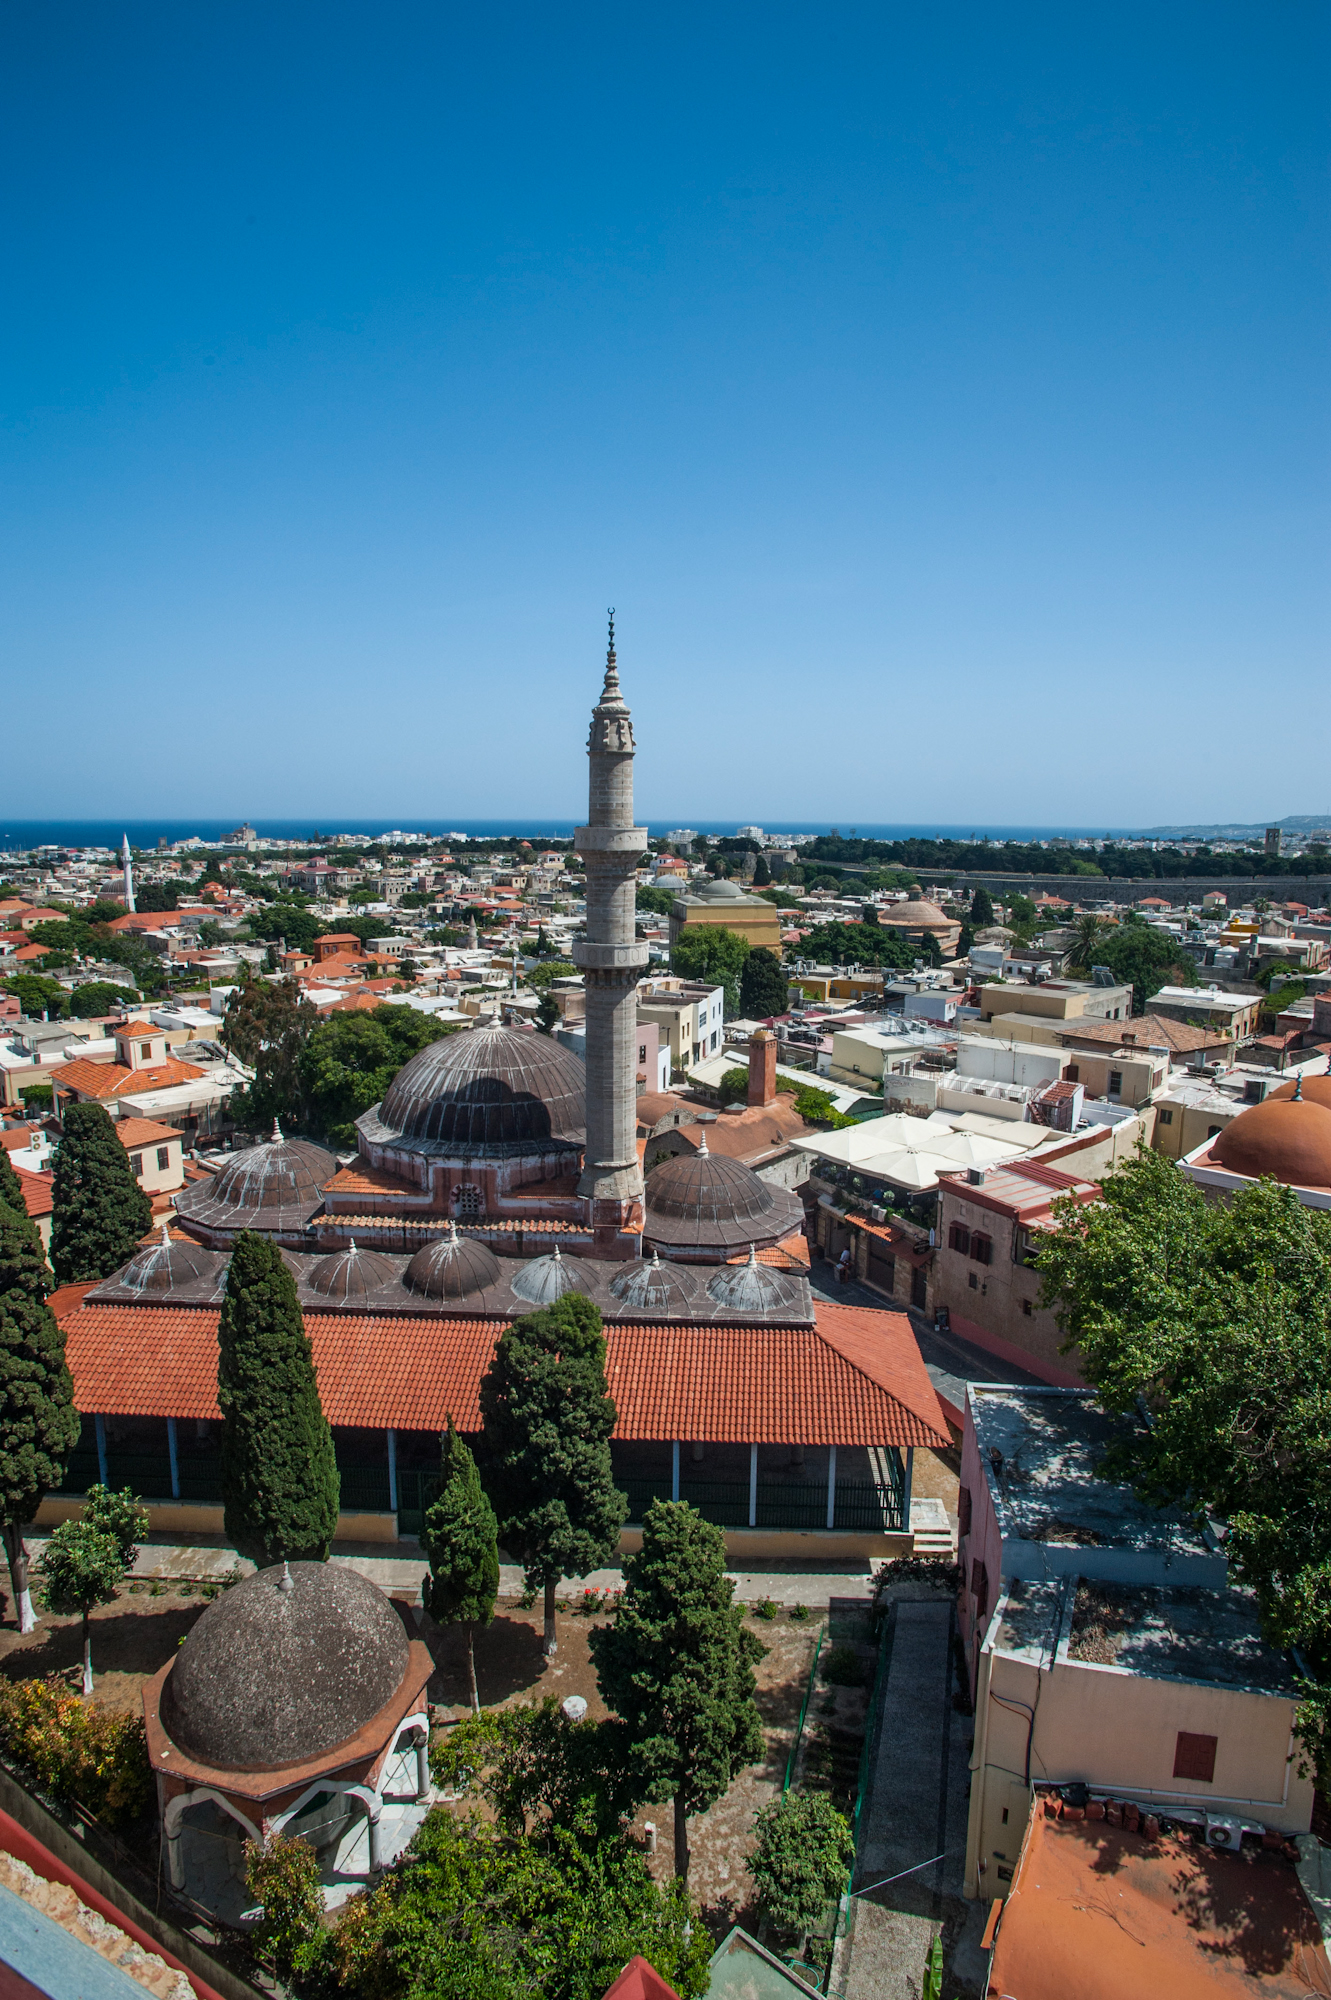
[218,1230,340,1568]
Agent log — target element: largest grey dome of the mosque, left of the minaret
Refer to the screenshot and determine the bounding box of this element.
[369,1022,588,1152]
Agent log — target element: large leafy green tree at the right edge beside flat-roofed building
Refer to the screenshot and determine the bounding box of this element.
[1039,1152,1331,1786]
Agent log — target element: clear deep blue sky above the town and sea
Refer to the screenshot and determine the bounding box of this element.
[0,0,1331,826]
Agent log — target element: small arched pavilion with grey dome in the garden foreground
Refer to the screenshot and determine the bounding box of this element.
[144,1562,434,1922]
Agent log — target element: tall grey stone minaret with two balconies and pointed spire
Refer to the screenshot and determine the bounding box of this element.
[574,610,648,1232]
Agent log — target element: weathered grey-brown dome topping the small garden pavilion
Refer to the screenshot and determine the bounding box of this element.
[160,1562,408,1770]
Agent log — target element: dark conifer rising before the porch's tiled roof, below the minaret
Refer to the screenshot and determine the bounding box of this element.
[480,1292,628,1656]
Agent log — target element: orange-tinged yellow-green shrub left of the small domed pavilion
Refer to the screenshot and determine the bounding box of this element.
[0,1676,152,1826]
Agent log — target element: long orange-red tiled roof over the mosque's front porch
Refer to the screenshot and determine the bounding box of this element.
[51,1302,947,1446]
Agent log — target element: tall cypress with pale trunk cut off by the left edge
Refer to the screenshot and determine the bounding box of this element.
[0,1202,80,1632]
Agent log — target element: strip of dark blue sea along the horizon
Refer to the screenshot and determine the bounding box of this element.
[0,814,1131,852]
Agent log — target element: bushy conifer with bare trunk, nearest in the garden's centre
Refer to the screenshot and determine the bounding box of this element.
[590,1500,765,1876]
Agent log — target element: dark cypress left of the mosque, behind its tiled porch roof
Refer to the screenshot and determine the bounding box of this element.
[50,1104,152,1284]
